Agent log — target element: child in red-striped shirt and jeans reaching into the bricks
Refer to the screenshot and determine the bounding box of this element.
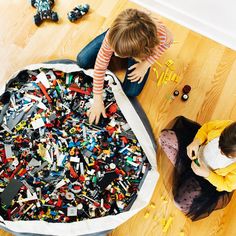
[77,9,173,123]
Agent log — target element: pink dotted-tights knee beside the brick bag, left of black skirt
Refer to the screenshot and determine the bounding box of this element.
[159,130,178,165]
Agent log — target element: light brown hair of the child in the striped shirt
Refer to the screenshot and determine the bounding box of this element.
[108,9,159,59]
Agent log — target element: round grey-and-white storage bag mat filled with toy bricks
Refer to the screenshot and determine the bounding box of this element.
[0,60,159,236]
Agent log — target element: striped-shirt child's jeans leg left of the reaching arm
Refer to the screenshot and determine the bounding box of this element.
[77,31,107,69]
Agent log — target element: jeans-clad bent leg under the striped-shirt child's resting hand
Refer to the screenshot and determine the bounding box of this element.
[122,58,150,97]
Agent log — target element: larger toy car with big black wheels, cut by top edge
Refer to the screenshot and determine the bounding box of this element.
[31,0,58,26]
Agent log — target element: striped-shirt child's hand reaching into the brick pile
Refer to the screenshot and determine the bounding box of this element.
[87,95,107,124]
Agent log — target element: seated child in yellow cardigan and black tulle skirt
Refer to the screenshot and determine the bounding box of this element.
[159,117,236,220]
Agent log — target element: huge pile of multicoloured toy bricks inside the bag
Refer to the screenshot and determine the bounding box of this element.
[0,69,150,222]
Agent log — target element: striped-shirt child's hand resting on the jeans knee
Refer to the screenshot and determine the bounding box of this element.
[128,61,151,84]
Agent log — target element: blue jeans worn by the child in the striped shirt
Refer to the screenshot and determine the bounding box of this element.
[77,31,150,97]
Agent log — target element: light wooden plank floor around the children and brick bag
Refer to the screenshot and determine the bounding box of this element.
[0,0,236,236]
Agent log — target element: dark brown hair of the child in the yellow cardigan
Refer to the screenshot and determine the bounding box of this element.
[219,122,236,156]
